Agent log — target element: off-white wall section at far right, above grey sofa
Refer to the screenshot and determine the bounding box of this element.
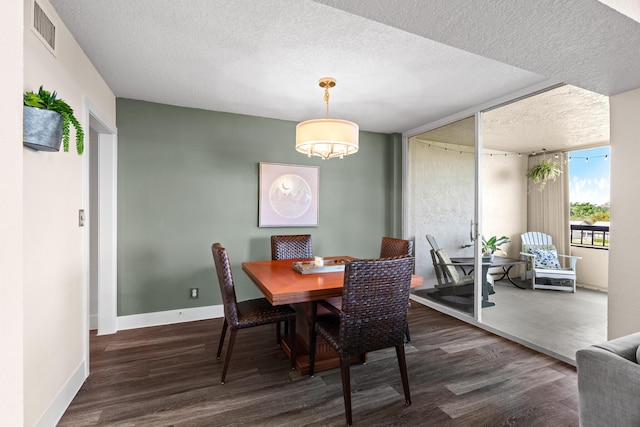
[608,89,640,339]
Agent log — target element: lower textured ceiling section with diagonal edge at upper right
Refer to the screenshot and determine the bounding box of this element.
[317,0,640,95]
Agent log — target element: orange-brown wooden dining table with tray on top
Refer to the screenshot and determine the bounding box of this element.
[242,255,422,375]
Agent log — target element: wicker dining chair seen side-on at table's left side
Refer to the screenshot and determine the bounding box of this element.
[211,243,296,384]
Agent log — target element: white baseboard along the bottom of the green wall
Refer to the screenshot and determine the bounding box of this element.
[118,304,224,331]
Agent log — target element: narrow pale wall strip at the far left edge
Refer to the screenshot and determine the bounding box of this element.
[0,1,24,426]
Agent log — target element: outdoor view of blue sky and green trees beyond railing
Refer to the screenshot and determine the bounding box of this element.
[569,146,610,246]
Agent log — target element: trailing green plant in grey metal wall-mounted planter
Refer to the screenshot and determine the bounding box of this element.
[23,86,84,154]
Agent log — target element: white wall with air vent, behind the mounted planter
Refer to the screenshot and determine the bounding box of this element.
[21,0,115,426]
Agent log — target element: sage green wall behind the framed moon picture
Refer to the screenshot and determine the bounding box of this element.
[116,98,402,316]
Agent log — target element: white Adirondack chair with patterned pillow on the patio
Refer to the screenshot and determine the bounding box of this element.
[520,231,582,292]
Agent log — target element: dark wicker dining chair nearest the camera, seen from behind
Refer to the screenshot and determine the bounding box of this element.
[309,255,414,425]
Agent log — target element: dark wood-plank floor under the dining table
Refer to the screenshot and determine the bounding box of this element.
[59,302,578,427]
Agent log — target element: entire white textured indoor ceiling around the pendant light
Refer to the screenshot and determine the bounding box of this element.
[50,0,624,151]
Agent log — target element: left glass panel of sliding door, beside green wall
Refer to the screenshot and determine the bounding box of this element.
[406,116,487,317]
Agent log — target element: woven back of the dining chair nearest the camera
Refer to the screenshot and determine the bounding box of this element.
[337,255,414,356]
